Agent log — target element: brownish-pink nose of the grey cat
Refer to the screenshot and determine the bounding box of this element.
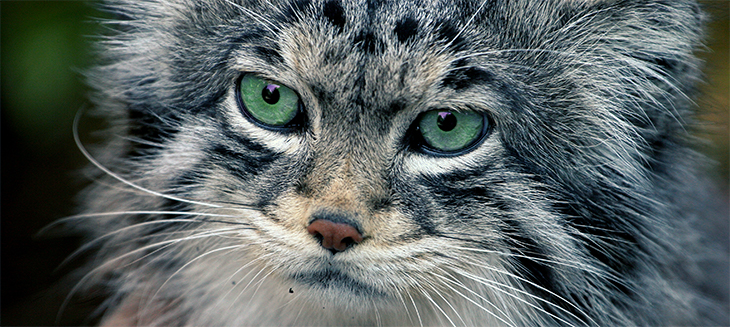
[307,219,362,254]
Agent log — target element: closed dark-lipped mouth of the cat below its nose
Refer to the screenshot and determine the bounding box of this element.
[292,268,386,297]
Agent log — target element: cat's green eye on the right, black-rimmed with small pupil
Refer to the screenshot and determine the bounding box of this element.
[418,109,488,154]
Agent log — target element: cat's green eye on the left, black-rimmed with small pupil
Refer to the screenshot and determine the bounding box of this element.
[238,75,300,128]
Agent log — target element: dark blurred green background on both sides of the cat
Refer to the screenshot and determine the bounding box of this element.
[0,0,730,326]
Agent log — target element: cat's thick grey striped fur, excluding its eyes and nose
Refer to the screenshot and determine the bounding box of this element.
[67,0,726,326]
